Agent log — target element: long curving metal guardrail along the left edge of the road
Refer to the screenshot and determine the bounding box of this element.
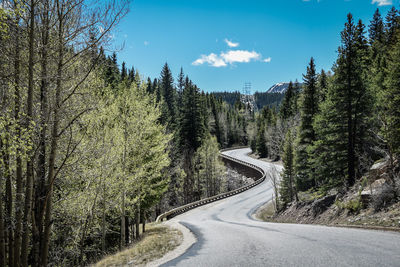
[156,147,266,222]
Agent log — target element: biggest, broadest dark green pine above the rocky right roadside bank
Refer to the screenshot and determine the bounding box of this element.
[313,14,370,186]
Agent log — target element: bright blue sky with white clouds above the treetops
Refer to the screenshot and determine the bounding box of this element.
[113,0,400,92]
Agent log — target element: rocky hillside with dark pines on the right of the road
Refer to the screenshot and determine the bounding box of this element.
[251,7,400,222]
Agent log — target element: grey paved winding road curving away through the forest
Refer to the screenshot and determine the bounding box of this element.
[162,148,400,267]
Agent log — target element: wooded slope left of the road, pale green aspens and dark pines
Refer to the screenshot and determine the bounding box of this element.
[0,0,254,266]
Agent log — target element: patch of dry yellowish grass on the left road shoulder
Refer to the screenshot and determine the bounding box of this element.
[93,224,183,267]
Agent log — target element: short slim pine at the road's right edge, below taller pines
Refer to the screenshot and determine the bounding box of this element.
[279,130,297,208]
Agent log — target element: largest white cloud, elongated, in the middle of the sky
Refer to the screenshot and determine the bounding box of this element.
[192,50,271,68]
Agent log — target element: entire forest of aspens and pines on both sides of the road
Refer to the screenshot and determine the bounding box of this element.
[0,0,400,266]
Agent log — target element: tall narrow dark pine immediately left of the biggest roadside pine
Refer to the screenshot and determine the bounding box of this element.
[295,58,319,190]
